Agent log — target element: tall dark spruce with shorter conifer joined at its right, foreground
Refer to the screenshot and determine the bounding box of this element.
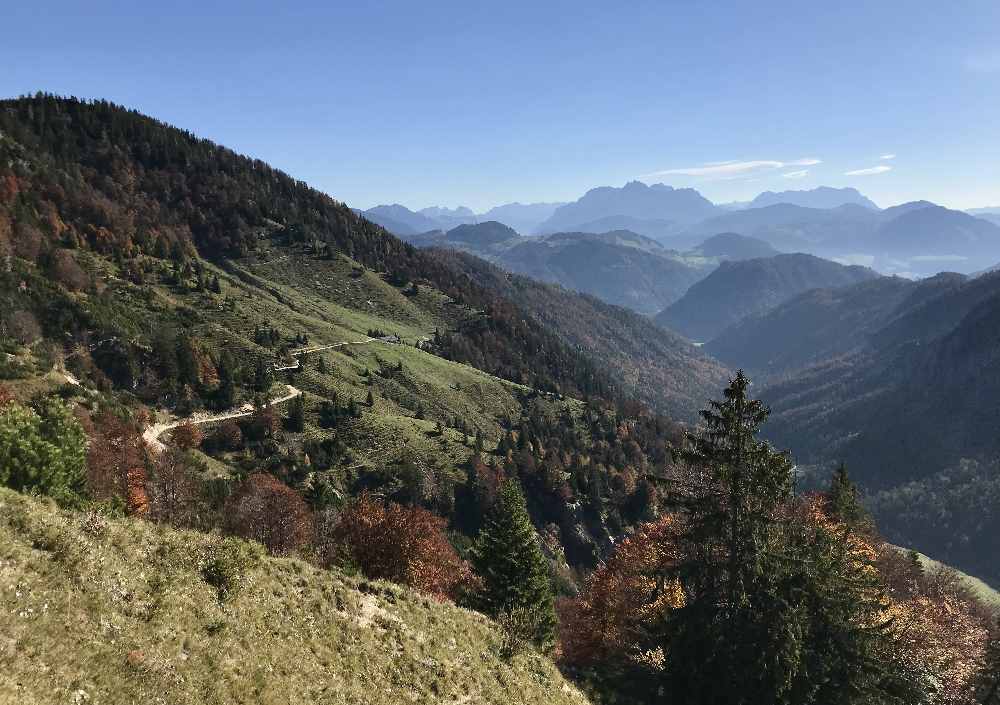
[662,371,919,705]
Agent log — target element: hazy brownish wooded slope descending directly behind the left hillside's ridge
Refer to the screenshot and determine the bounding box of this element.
[428,250,732,422]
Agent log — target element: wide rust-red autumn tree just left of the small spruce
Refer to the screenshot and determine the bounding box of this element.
[324,494,469,600]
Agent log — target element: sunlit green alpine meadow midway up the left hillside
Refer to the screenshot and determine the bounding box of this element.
[64,234,580,470]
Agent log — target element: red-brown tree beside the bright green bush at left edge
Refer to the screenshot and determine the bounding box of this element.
[87,410,149,516]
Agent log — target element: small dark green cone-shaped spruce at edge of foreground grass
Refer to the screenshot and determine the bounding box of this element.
[472,480,556,650]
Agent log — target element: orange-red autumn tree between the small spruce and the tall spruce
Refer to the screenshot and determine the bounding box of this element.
[558,515,682,665]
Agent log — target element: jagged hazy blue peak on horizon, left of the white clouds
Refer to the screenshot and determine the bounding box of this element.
[537,181,718,233]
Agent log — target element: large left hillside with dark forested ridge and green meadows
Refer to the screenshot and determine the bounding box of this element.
[0,97,692,566]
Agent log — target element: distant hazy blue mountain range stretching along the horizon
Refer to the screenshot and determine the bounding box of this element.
[365,187,1000,277]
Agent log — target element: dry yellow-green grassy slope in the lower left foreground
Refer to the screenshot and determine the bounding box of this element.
[0,489,586,704]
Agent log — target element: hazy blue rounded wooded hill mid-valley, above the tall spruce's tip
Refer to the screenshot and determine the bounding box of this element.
[656,254,878,341]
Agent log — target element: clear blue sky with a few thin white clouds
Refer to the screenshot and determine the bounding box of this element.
[0,0,1000,212]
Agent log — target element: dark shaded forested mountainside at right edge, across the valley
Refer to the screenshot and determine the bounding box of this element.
[708,274,1000,584]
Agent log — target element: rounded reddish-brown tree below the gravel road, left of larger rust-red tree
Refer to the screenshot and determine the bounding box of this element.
[224,473,313,555]
